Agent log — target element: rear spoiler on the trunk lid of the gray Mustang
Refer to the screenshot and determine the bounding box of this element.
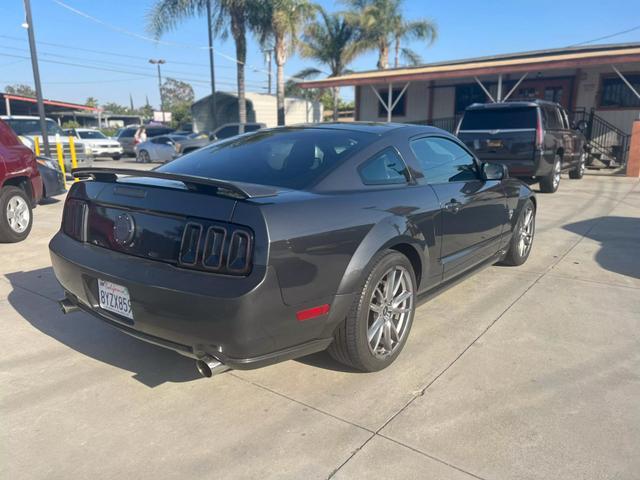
[72,167,278,199]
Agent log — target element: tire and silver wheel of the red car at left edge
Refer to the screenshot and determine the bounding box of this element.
[0,187,33,243]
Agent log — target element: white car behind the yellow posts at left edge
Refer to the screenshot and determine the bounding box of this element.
[0,115,93,171]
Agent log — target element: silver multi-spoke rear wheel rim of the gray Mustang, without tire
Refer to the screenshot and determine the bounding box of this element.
[367,266,413,358]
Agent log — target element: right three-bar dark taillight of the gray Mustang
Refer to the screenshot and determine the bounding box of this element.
[178,222,253,275]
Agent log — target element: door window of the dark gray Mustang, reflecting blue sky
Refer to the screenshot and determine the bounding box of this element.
[411,137,478,184]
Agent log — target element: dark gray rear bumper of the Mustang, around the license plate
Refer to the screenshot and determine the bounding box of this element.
[50,233,353,369]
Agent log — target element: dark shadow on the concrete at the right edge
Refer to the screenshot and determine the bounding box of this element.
[564,216,640,279]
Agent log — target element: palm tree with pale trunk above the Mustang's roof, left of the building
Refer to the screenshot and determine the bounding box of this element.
[250,0,317,125]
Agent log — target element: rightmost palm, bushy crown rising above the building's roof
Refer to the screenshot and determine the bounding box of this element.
[344,0,437,70]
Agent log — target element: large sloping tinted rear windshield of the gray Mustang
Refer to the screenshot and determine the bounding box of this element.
[158,128,377,189]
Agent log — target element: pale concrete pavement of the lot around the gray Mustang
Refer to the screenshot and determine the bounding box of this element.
[0,162,640,479]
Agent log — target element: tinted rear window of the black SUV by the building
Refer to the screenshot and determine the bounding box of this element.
[460,107,538,130]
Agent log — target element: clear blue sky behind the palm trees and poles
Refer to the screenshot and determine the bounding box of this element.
[0,0,640,106]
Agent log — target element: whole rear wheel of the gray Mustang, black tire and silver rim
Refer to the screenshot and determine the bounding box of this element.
[329,250,417,372]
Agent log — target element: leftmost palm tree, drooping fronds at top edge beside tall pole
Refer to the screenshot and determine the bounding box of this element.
[147,0,252,124]
